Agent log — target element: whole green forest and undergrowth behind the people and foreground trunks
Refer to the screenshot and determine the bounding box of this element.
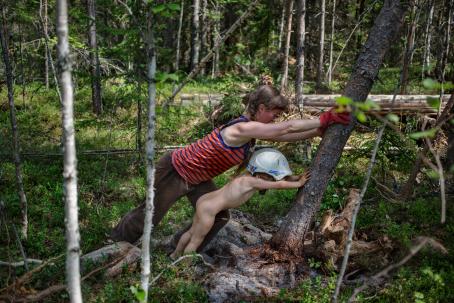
[0,0,454,302]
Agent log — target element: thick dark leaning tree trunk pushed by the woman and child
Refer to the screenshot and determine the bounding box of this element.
[271,0,407,256]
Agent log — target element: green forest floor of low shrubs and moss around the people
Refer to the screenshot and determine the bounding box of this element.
[0,76,454,302]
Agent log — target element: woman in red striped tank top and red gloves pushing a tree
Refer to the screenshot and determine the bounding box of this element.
[111,85,350,251]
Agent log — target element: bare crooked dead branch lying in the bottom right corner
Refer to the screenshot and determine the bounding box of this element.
[348,237,448,302]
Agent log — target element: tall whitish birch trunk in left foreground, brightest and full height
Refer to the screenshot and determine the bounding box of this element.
[57,0,82,302]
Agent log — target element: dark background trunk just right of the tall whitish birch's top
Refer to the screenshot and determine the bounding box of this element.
[87,0,102,116]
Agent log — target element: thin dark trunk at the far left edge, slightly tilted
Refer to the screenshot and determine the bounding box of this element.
[0,7,28,239]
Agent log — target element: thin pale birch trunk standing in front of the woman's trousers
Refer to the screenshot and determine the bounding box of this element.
[141,7,156,302]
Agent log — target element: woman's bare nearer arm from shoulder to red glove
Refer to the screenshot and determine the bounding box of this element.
[222,119,320,146]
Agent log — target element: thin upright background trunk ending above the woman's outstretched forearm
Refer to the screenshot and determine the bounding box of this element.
[295,0,306,112]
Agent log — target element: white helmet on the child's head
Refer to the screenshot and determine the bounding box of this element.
[247,148,292,181]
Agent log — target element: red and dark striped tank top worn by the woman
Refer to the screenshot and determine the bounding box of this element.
[172,116,255,185]
